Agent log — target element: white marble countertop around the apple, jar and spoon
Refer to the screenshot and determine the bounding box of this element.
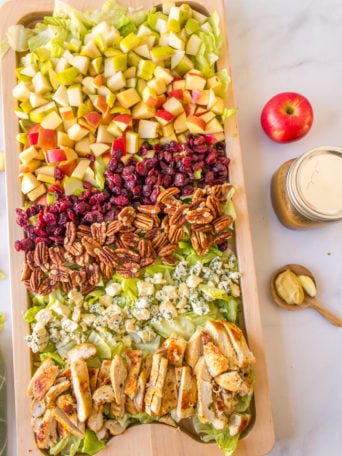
[0,0,342,456]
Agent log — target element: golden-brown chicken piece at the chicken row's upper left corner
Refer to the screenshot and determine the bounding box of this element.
[26,358,59,401]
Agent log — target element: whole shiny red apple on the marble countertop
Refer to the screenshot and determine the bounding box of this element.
[260,92,313,143]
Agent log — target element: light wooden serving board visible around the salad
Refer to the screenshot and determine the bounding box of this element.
[0,0,274,456]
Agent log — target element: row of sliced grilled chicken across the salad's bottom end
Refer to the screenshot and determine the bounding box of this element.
[28,321,255,454]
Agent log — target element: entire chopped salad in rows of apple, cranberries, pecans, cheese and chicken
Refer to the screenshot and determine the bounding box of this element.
[0,0,255,456]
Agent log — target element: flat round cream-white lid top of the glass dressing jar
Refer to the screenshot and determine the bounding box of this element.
[297,150,342,216]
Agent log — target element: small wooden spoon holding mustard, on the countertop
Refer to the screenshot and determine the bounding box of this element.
[271,264,342,327]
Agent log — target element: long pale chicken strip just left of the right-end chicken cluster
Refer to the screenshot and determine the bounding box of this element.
[195,356,216,423]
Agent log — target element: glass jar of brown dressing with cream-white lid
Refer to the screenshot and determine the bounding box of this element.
[271,146,342,229]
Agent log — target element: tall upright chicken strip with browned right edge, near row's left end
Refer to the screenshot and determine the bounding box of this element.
[70,358,92,423]
